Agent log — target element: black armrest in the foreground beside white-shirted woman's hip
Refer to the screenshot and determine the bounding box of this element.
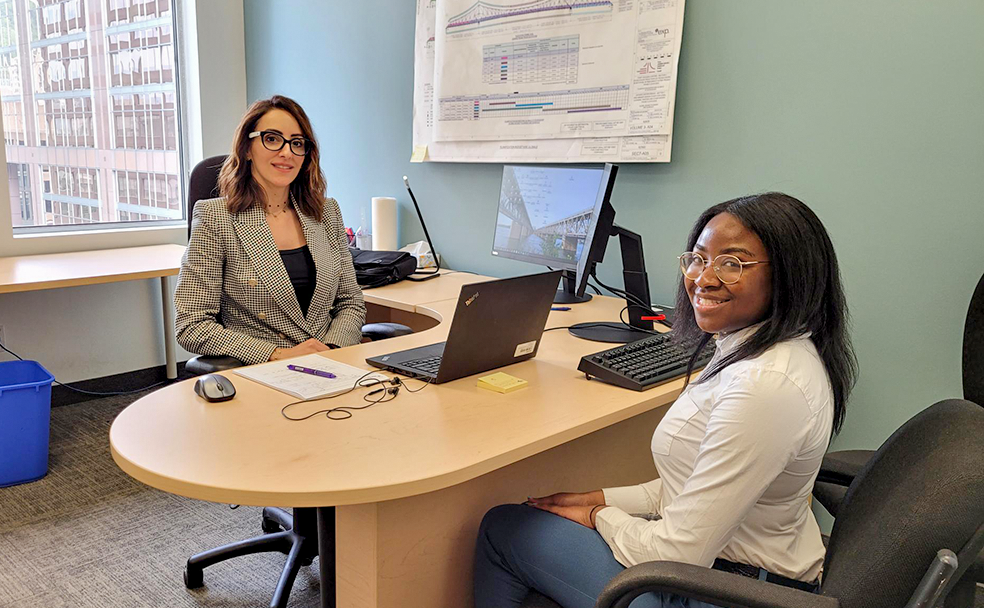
[595,562,840,608]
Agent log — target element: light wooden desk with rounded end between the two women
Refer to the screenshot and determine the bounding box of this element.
[110,279,682,607]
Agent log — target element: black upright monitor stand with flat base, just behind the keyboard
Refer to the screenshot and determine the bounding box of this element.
[567,225,653,344]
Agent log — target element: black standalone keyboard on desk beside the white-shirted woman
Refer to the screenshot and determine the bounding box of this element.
[577,334,714,391]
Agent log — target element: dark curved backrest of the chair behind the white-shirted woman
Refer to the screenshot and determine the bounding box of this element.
[821,399,984,608]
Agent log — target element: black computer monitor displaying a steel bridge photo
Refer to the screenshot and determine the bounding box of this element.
[492,165,614,304]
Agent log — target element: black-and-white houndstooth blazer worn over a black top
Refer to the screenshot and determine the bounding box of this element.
[174,198,366,365]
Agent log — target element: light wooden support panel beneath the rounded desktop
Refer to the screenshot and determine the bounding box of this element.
[332,408,666,608]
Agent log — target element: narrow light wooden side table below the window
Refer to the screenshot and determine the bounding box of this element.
[0,245,185,379]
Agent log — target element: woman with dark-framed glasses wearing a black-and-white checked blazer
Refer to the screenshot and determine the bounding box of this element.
[174,95,366,365]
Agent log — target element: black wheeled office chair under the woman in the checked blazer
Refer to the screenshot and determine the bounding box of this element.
[184,155,413,608]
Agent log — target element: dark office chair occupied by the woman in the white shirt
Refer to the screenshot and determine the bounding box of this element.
[524,399,984,608]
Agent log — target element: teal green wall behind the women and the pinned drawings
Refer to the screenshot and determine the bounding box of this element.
[245,0,984,460]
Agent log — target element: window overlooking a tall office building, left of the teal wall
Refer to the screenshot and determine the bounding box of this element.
[0,0,184,231]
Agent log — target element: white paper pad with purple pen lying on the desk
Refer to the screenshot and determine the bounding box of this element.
[233,354,387,401]
